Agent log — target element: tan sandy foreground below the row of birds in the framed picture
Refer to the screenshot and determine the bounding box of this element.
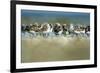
[21,37,90,63]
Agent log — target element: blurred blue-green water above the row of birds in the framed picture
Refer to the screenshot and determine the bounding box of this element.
[21,10,90,25]
